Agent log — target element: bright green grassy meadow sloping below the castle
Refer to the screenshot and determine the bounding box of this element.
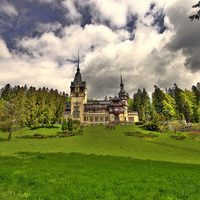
[0,125,200,200]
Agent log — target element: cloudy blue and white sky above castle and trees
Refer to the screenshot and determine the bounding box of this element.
[0,0,200,99]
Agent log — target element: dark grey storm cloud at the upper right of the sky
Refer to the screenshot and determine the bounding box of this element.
[166,0,200,73]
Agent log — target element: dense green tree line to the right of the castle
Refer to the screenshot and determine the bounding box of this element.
[128,82,200,122]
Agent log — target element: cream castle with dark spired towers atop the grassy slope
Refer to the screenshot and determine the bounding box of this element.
[64,62,138,125]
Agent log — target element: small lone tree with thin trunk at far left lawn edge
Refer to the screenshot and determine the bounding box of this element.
[0,101,20,141]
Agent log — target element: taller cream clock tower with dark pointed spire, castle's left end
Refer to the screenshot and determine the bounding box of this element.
[70,57,87,122]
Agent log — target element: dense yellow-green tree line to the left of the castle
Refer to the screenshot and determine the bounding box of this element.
[0,84,68,128]
